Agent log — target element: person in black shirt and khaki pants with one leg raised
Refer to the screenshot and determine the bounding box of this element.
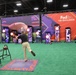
[15,31,36,62]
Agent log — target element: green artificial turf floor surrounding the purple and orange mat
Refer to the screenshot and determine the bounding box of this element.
[0,42,76,75]
